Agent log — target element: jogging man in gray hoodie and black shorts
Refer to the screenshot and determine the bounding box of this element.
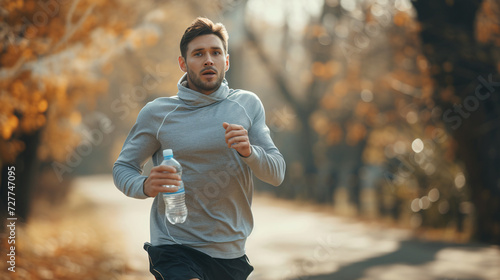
[113,18,285,280]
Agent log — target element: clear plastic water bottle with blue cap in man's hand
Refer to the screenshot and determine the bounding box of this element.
[161,149,187,225]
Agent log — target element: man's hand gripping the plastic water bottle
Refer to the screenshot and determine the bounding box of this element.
[143,165,181,197]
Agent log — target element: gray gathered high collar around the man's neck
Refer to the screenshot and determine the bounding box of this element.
[177,73,229,107]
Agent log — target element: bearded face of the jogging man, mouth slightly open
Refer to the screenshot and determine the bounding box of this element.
[179,34,229,94]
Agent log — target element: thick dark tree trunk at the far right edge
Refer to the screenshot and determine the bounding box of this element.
[413,0,500,244]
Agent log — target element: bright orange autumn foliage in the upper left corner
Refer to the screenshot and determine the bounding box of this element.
[0,0,133,164]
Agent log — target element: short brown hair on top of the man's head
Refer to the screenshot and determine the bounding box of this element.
[180,17,229,58]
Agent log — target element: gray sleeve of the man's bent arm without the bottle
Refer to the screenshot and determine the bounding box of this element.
[242,95,286,186]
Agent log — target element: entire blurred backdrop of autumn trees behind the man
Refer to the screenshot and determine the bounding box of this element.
[0,0,500,243]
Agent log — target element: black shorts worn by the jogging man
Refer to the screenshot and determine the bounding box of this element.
[144,243,253,280]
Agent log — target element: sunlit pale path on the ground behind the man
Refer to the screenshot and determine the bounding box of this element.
[75,175,500,280]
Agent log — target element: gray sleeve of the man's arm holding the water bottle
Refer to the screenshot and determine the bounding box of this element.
[113,106,161,199]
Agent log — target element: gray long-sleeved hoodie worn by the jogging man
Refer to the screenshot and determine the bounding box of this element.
[113,75,285,259]
